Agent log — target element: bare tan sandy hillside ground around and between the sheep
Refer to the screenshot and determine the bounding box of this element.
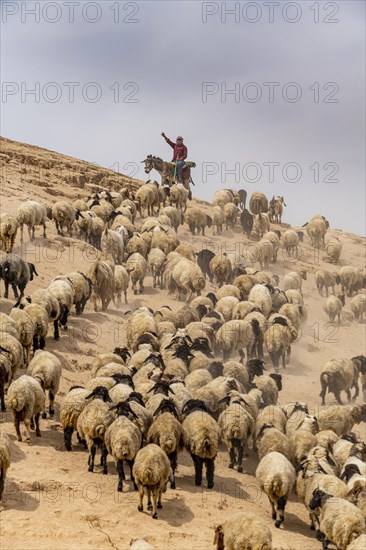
[0,140,365,550]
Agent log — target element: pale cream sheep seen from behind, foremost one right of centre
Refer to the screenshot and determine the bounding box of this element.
[255,451,295,528]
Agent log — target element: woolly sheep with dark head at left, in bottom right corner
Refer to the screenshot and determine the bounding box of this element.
[309,489,365,550]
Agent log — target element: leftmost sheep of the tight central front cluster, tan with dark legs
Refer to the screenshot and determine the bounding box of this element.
[60,386,90,451]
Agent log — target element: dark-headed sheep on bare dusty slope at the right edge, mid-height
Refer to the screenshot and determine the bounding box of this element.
[319,357,366,405]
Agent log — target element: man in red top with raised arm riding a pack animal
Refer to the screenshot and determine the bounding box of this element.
[142,132,196,199]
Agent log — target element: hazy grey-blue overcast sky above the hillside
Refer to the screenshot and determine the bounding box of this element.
[0,0,365,234]
